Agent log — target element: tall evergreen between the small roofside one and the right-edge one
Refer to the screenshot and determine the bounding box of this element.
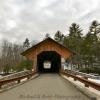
[68,23,82,53]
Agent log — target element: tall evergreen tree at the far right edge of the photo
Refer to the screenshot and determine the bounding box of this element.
[82,20,100,66]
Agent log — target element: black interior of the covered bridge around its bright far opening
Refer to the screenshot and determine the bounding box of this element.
[37,51,61,73]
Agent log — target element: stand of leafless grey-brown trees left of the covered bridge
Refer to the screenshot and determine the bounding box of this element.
[0,40,24,74]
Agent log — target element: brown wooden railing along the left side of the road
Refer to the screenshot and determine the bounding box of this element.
[0,71,37,88]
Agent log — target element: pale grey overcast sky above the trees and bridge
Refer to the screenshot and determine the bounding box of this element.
[0,0,100,42]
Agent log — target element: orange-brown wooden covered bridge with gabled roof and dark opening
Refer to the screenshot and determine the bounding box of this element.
[22,37,74,72]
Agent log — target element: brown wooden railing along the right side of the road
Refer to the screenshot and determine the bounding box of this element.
[60,71,100,91]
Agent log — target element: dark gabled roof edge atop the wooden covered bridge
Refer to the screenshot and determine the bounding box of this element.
[21,37,75,56]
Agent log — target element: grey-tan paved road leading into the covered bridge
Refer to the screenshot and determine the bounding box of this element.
[0,74,90,100]
